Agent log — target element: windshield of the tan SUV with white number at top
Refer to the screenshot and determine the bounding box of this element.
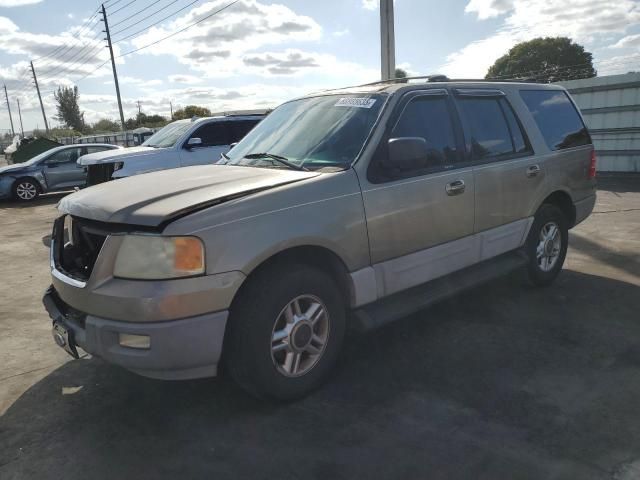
[221,94,385,170]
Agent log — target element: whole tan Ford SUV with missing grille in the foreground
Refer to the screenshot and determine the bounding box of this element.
[44,82,596,399]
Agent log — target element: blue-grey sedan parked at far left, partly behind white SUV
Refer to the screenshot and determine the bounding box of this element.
[0,143,122,201]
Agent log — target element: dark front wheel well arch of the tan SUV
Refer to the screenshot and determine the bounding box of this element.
[245,245,352,305]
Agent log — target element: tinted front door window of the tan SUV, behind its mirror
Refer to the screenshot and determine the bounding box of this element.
[391,96,458,167]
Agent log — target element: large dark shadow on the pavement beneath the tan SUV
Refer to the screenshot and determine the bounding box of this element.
[0,271,640,480]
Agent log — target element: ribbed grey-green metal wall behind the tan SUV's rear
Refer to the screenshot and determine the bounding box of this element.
[560,73,640,172]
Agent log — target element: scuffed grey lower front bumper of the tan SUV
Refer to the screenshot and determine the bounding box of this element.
[42,286,228,380]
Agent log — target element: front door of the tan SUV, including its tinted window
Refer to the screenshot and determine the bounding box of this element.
[362,89,475,297]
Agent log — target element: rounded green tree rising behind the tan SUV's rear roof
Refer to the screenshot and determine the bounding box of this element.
[485,37,597,83]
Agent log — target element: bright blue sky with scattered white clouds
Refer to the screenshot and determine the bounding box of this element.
[0,0,640,133]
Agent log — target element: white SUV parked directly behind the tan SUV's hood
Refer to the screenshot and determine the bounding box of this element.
[79,115,265,186]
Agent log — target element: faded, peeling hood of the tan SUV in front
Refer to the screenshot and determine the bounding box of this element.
[58,165,319,227]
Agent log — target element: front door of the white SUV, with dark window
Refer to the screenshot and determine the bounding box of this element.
[180,121,231,167]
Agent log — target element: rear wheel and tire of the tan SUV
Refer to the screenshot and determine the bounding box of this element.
[525,204,569,286]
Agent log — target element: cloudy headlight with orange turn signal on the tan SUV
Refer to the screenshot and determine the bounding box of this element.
[113,235,205,280]
